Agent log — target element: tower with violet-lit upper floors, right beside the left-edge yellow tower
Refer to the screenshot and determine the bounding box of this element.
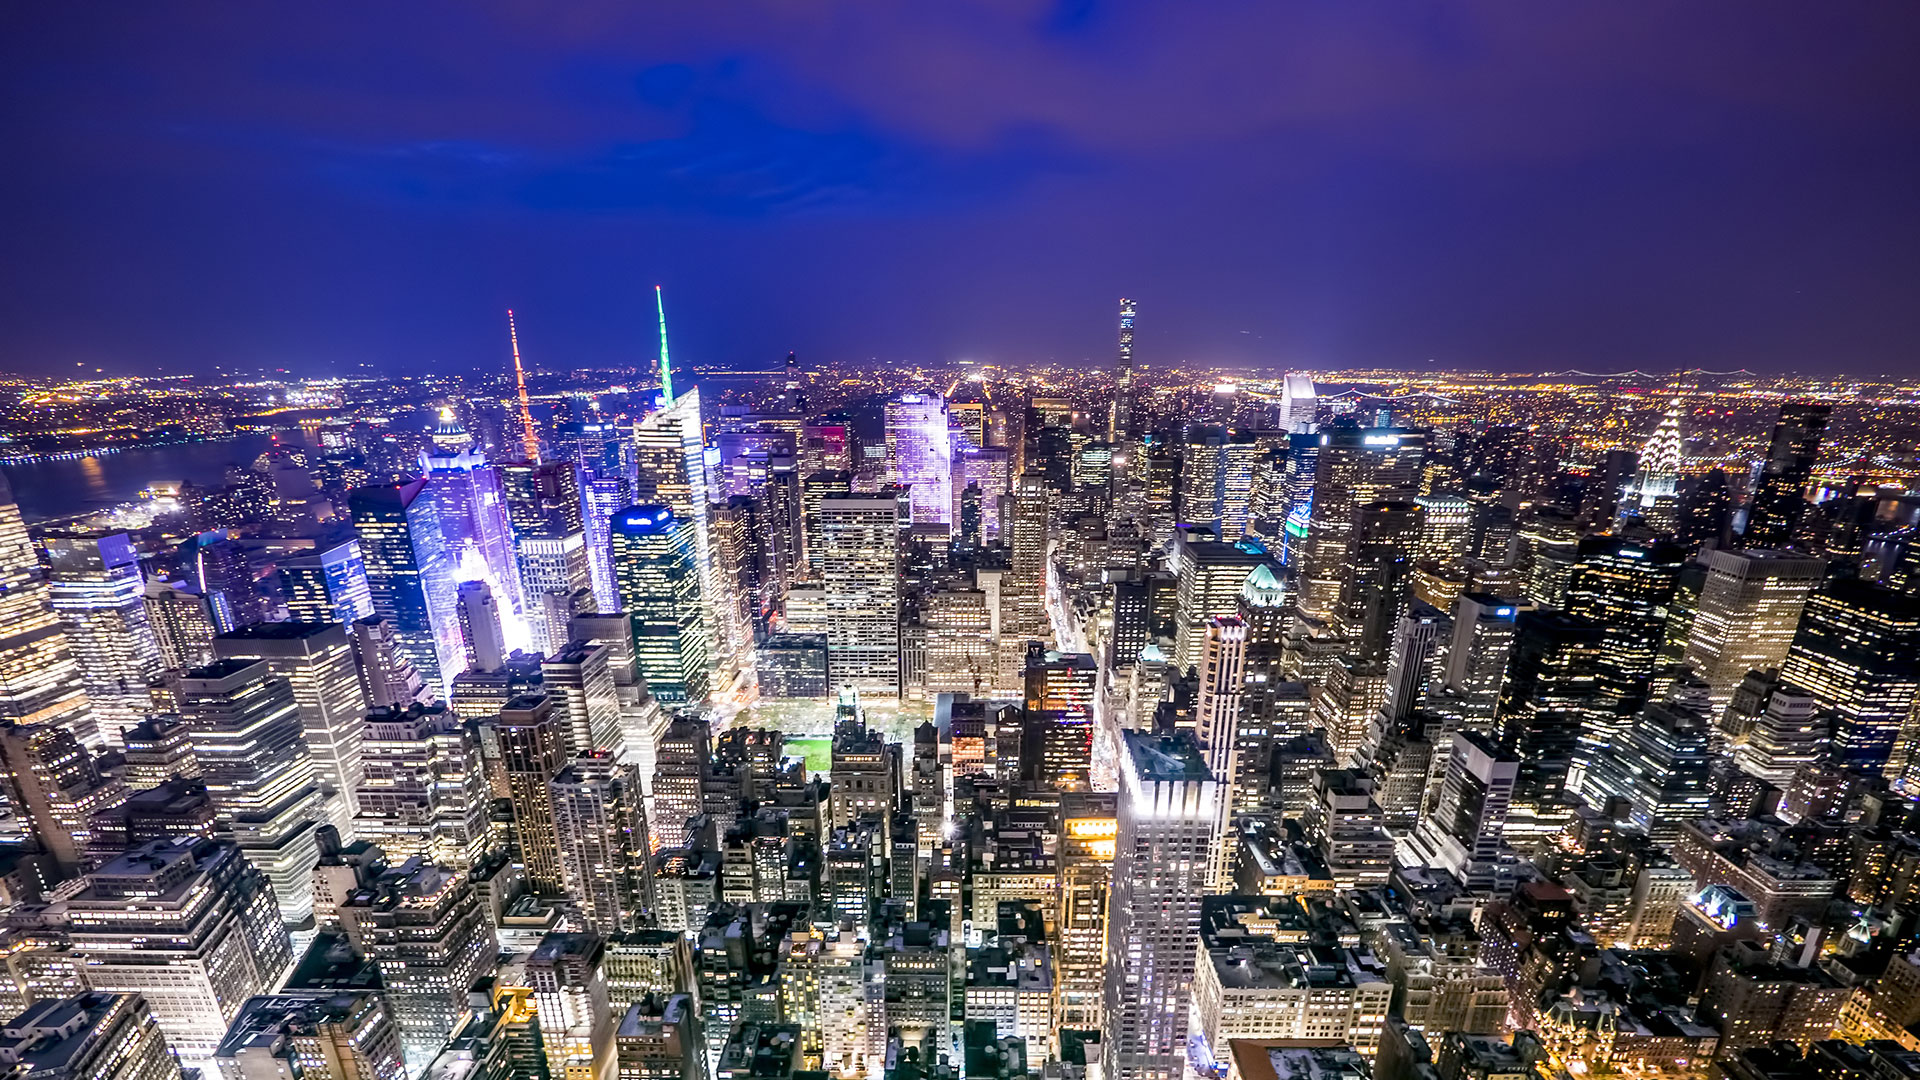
[46,532,161,742]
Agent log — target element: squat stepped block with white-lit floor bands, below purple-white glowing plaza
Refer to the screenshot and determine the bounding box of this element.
[353,703,492,867]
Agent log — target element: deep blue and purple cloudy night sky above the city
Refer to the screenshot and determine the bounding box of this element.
[0,0,1920,375]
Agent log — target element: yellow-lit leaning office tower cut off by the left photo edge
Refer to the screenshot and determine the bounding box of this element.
[0,477,104,748]
